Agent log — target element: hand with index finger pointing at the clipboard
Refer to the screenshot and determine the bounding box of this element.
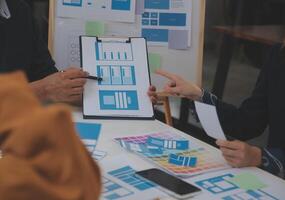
[155,70,202,100]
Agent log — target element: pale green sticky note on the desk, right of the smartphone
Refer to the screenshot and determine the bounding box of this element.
[228,173,266,190]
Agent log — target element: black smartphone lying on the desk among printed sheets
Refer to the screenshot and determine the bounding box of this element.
[136,168,201,199]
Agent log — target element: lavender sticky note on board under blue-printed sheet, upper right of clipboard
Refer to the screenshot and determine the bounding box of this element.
[168,30,189,50]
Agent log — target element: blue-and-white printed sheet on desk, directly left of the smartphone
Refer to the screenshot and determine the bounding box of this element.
[99,155,167,200]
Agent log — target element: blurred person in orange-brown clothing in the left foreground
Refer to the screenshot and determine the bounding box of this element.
[0,73,101,200]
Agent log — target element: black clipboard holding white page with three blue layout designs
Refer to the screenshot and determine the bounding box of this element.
[80,36,154,120]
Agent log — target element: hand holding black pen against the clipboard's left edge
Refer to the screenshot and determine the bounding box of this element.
[41,68,88,103]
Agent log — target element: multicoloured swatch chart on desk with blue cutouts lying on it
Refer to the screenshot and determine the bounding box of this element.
[115,131,229,178]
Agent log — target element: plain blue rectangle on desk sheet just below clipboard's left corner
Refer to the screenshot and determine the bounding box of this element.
[75,122,101,140]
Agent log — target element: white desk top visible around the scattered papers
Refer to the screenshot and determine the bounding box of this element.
[73,111,285,200]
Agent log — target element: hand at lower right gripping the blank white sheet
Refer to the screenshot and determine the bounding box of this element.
[216,140,261,167]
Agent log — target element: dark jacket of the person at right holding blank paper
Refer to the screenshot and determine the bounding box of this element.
[217,45,285,148]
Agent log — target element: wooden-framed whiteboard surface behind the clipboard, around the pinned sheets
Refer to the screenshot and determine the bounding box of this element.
[49,0,205,117]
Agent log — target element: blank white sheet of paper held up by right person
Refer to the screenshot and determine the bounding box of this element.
[195,101,227,140]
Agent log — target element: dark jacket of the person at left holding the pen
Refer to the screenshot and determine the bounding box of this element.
[0,0,57,81]
